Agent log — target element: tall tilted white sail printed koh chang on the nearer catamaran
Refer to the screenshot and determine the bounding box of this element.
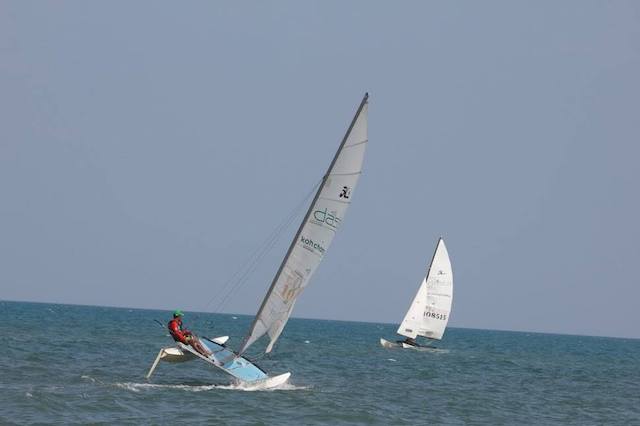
[239,94,369,354]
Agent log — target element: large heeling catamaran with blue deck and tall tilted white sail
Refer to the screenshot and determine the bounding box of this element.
[147,94,369,388]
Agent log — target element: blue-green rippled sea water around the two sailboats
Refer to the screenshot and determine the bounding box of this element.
[0,302,640,425]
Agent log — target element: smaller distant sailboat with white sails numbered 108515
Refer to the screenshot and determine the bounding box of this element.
[380,237,453,349]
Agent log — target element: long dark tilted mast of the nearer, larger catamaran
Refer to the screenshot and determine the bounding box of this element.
[238,93,369,355]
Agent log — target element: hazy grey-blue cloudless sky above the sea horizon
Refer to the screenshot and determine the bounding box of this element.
[0,0,640,337]
